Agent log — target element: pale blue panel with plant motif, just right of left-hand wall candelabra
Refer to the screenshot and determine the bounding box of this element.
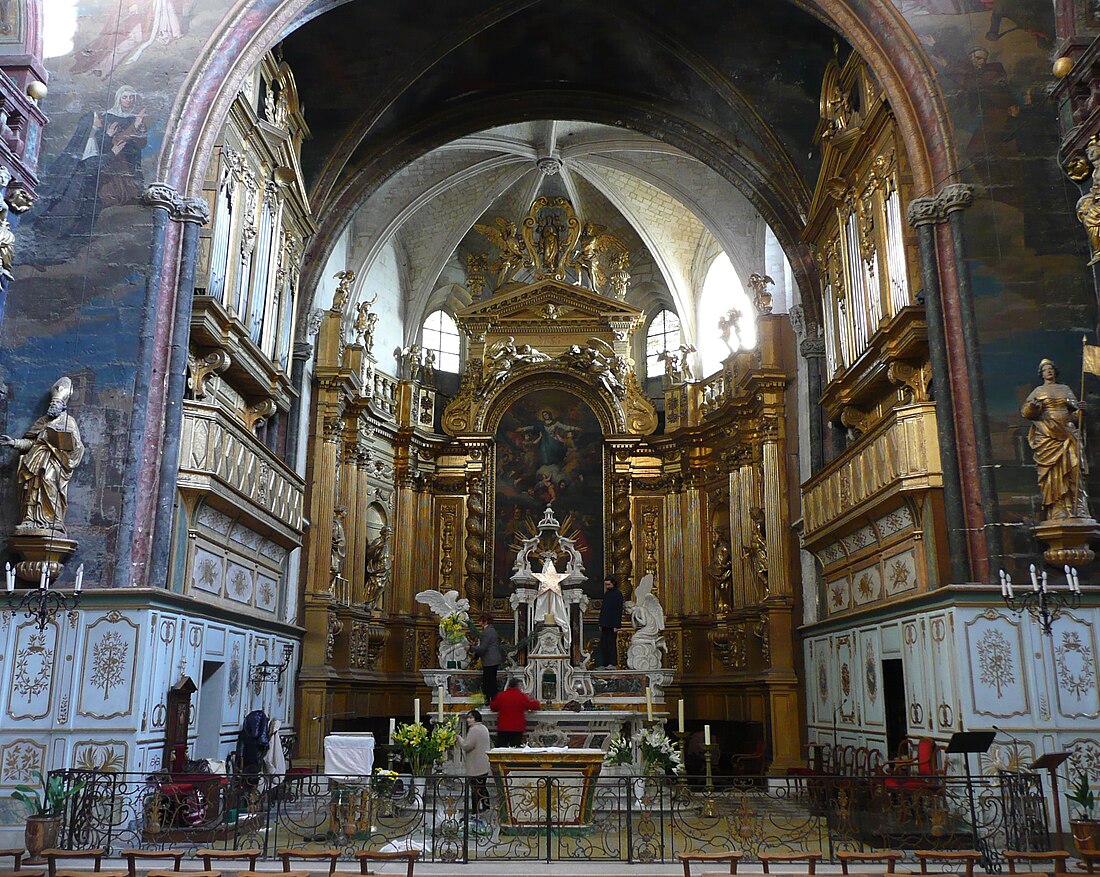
[77,612,139,719]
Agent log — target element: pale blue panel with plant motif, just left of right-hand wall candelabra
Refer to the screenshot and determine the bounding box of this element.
[966,610,1031,719]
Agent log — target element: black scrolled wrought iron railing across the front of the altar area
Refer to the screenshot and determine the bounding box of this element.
[51,770,1049,870]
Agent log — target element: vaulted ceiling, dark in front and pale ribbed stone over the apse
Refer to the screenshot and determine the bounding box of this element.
[282,0,846,332]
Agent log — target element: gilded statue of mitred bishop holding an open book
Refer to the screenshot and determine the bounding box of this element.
[0,377,84,536]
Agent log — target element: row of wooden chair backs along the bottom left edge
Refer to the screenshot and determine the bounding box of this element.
[0,848,420,877]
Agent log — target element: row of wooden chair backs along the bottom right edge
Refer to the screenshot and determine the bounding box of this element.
[678,849,1069,877]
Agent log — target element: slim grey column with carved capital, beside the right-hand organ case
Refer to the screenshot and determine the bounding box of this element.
[909,198,970,583]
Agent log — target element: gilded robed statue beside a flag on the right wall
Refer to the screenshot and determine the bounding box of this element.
[1020,360,1089,520]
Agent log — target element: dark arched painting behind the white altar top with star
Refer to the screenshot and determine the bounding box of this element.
[493,390,604,598]
